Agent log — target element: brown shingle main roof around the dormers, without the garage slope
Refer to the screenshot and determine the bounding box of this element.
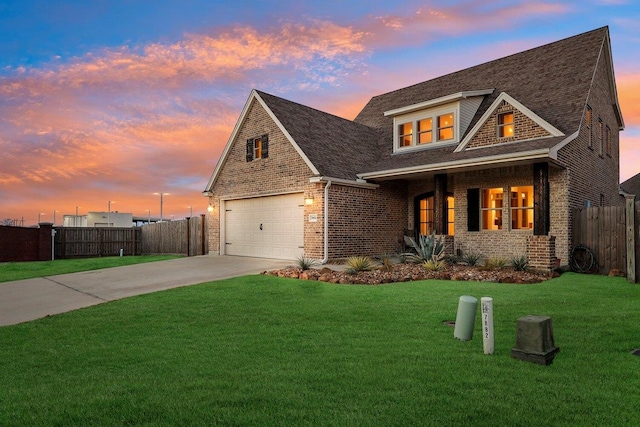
[355,27,608,177]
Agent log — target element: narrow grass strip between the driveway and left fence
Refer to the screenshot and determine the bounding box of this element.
[0,255,179,282]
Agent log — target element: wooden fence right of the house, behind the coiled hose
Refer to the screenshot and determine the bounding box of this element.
[573,197,640,282]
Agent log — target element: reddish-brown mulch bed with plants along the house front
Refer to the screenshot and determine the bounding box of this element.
[262,264,558,285]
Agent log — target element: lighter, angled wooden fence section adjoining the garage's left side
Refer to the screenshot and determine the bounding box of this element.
[141,215,209,256]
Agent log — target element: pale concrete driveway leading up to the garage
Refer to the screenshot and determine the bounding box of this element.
[0,255,295,326]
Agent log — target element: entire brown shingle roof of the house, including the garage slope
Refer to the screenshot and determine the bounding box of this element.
[258,27,609,179]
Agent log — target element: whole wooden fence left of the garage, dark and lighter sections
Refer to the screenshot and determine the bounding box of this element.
[55,215,209,258]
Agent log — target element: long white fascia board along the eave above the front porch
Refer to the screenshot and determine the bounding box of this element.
[358,148,549,179]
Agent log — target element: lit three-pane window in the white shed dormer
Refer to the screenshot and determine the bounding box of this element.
[394,110,458,150]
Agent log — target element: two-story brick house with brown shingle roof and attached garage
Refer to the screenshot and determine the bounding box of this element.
[204,27,624,269]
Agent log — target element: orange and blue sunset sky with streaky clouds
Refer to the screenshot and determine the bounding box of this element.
[0,0,640,225]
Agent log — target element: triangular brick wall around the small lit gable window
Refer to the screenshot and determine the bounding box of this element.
[467,101,550,148]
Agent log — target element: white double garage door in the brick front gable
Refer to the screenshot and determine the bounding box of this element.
[224,193,304,259]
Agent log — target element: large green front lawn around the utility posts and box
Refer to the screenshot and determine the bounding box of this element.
[0,273,640,427]
